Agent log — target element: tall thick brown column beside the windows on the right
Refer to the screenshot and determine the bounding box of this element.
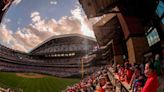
[117,13,148,63]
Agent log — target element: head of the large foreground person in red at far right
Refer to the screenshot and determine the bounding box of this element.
[145,62,154,77]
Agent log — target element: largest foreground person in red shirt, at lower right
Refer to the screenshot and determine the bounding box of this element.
[142,62,158,92]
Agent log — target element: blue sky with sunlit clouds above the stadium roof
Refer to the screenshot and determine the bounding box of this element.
[0,0,95,52]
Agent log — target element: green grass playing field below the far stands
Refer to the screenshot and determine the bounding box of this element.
[0,72,79,92]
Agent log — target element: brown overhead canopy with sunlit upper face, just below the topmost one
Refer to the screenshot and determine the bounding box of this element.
[93,14,119,46]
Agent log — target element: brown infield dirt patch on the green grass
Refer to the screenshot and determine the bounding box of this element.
[16,73,46,78]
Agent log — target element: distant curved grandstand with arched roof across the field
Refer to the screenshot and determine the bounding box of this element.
[0,34,97,77]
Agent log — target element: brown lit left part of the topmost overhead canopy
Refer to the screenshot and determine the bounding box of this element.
[79,0,117,18]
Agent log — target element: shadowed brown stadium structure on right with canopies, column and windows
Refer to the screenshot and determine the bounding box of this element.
[79,0,164,64]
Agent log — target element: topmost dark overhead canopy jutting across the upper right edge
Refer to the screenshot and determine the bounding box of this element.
[79,0,159,18]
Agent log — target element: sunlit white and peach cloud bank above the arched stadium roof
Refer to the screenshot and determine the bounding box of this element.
[0,7,94,52]
